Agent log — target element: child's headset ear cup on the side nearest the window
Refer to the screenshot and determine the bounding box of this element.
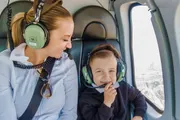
[117,61,126,82]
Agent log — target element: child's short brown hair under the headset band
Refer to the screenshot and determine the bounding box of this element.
[89,44,120,63]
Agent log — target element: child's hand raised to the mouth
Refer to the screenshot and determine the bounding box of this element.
[104,82,117,107]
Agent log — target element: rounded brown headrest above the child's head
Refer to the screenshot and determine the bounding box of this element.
[73,6,117,40]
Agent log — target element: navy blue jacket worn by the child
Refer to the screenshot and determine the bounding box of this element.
[78,81,147,120]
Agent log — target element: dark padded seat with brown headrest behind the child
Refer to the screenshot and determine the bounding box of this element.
[70,6,120,92]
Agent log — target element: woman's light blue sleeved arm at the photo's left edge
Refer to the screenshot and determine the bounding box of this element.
[0,61,17,120]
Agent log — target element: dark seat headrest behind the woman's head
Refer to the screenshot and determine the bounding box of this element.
[0,1,33,33]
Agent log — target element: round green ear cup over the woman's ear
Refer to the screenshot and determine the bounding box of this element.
[23,23,48,49]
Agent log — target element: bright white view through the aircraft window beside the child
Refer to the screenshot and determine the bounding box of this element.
[131,5,164,111]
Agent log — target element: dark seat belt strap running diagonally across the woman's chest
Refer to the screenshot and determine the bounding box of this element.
[18,57,56,120]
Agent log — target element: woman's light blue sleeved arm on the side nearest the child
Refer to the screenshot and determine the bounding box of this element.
[59,60,78,120]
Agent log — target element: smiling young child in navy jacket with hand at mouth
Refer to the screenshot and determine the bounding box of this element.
[79,44,147,120]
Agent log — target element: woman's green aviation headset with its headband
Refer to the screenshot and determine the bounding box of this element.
[23,0,49,49]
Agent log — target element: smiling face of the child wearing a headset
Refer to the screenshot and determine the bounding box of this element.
[90,56,117,86]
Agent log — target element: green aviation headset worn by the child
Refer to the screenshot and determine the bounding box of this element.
[82,46,126,84]
